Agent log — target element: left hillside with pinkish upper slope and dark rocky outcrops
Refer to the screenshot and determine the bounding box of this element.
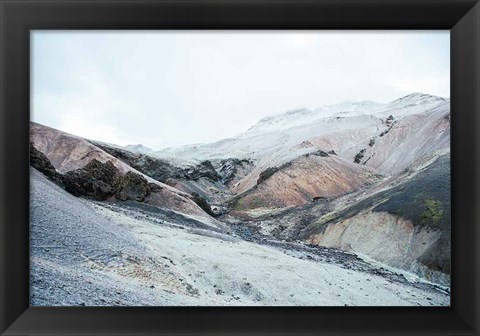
[30,123,216,216]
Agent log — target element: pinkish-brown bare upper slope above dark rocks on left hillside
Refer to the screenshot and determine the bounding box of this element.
[30,122,214,216]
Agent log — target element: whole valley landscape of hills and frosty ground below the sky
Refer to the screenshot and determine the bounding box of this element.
[30,93,451,306]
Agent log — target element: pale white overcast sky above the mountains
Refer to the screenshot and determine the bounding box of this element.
[31,31,450,149]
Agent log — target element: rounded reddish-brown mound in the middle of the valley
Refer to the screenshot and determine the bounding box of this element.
[233,151,379,210]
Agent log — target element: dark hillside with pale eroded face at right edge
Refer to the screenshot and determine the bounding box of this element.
[302,155,451,284]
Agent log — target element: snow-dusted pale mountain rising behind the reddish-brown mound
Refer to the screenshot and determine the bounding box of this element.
[149,94,450,194]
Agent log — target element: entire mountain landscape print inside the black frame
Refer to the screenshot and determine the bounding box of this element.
[30,30,451,307]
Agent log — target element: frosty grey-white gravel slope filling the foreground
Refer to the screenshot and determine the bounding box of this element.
[31,169,450,306]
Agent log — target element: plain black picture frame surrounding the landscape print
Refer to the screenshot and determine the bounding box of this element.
[0,0,480,335]
